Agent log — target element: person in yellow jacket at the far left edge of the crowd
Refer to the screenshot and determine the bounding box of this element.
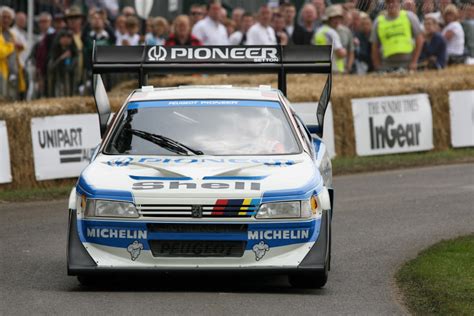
[0,7,26,99]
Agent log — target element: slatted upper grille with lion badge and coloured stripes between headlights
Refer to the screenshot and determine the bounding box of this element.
[137,199,260,218]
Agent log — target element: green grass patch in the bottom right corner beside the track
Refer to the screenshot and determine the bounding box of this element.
[396,234,474,315]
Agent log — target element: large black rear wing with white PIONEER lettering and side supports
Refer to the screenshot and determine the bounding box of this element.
[92,45,332,136]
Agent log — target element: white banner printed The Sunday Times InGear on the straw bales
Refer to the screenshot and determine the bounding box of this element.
[352,94,433,156]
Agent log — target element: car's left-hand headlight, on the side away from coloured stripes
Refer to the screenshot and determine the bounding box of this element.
[85,200,138,218]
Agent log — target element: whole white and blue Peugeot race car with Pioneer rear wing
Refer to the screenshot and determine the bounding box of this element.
[67,46,334,288]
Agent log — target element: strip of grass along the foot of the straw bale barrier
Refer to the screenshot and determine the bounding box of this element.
[0,148,474,202]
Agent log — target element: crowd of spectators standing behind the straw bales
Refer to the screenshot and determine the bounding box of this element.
[0,0,474,100]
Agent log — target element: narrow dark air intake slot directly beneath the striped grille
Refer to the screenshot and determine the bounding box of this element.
[147,224,248,233]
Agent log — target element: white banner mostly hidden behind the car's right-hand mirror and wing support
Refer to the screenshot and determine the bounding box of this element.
[292,102,336,158]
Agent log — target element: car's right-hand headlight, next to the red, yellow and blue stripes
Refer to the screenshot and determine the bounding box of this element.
[255,196,318,219]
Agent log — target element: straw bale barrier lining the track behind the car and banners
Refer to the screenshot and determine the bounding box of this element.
[0,66,474,190]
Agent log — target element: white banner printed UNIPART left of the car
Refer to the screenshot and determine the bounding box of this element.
[31,114,100,181]
